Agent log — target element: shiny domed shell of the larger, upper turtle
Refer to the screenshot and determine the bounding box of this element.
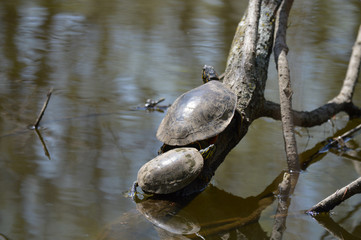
[157,81,237,146]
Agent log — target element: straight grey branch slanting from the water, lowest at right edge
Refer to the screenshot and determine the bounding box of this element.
[307,177,361,215]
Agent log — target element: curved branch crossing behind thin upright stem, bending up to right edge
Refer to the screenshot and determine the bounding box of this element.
[261,26,361,127]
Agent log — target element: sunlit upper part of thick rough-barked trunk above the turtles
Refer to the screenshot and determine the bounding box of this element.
[224,0,281,121]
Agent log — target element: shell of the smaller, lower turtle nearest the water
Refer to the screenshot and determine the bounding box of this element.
[137,148,203,194]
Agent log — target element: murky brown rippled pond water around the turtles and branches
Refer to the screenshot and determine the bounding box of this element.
[0,0,361,239]
